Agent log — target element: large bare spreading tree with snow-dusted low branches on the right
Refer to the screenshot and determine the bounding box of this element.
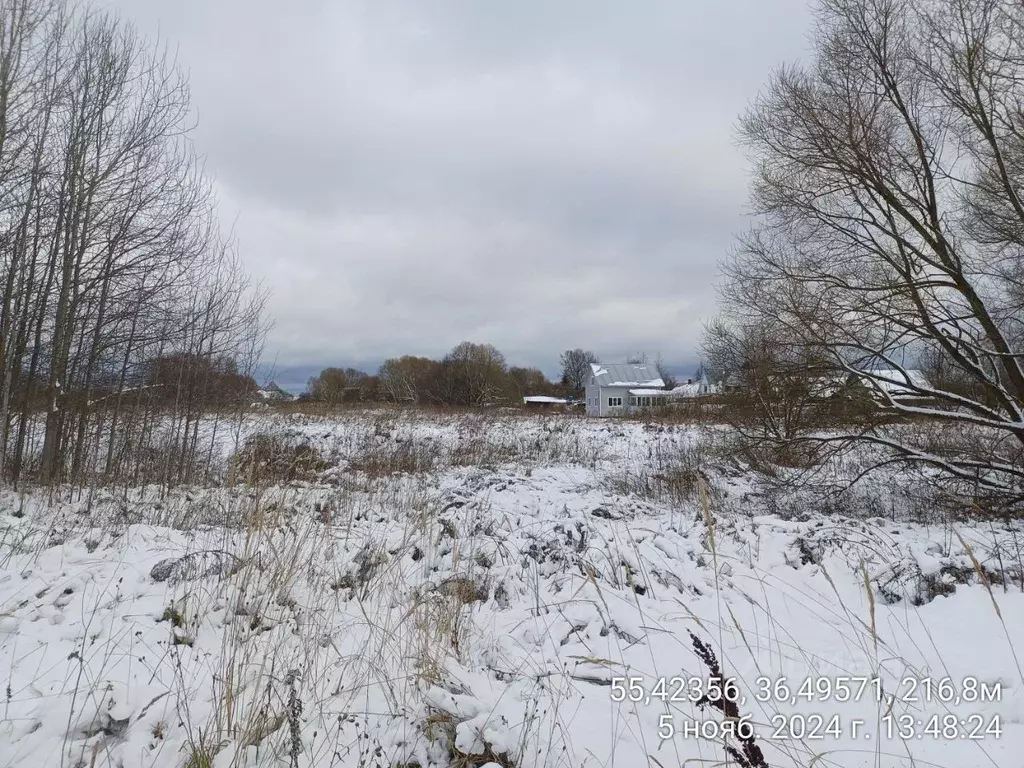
[722,0,1024,503]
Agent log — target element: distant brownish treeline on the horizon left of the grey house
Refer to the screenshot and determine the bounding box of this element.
[304,341,572,407]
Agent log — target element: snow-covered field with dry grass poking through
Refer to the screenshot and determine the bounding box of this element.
[0,414,1024,768]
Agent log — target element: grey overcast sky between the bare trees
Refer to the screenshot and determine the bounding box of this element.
[109,0,810,391]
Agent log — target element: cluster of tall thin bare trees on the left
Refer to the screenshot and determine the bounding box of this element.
[0,0,264,483]
